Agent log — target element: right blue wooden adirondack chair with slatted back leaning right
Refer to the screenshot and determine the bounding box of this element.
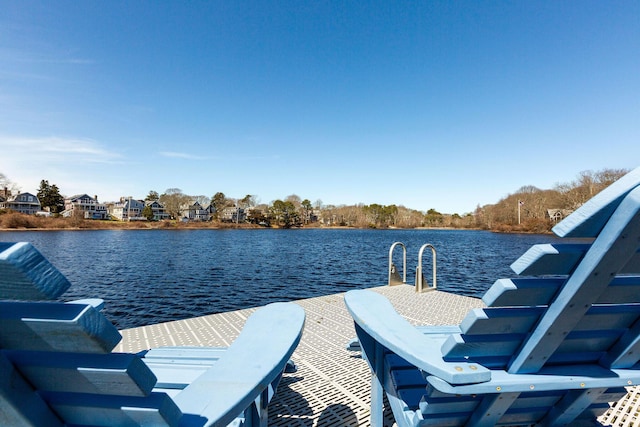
[345,168,640,426]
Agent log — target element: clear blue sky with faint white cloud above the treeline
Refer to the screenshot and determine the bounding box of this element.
[0,0,640,214]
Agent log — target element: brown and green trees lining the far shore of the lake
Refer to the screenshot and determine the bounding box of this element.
[0,169,628,233]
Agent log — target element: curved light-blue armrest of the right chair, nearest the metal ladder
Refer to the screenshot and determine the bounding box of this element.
[345,290,491,384]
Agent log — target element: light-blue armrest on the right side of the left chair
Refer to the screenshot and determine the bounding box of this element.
[174,303,305,425]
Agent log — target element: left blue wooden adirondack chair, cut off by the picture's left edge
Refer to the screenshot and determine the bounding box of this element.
[0,242,305,427]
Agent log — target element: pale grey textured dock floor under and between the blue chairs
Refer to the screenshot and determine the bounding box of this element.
[115,285,640,427]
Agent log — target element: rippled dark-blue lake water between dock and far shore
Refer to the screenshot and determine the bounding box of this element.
[0,229,554,329]
